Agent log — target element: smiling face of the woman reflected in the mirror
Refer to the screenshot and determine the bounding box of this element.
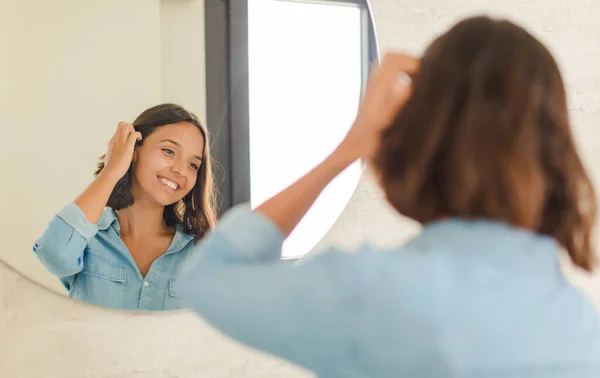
[132,122,204,206]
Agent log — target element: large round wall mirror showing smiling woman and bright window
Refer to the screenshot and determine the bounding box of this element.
[0,0,377,311]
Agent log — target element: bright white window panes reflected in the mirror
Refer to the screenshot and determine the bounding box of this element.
[248,0,366,258]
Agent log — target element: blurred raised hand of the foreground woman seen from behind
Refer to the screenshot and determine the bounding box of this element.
[338,53,419,159]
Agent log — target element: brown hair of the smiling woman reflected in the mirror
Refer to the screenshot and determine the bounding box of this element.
[95,104,217,239]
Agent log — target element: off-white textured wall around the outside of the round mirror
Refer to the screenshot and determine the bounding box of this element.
[0,0,600,378]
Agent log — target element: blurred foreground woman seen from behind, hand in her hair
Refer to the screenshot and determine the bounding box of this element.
[178,17,600,378]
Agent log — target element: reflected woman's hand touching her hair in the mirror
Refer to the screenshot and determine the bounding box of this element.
[103,122,142,180]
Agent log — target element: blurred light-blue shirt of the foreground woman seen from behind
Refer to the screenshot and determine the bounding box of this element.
[178,207,600,378]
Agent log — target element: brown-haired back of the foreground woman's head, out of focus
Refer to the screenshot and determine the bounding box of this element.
[373,17,596,270]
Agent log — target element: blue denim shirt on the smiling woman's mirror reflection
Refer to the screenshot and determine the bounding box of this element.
[33,203,194,311]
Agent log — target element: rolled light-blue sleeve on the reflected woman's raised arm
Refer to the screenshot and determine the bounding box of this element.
[33,203,98,278]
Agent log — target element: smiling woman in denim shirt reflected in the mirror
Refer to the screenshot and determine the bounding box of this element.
[33,104,215,311]
